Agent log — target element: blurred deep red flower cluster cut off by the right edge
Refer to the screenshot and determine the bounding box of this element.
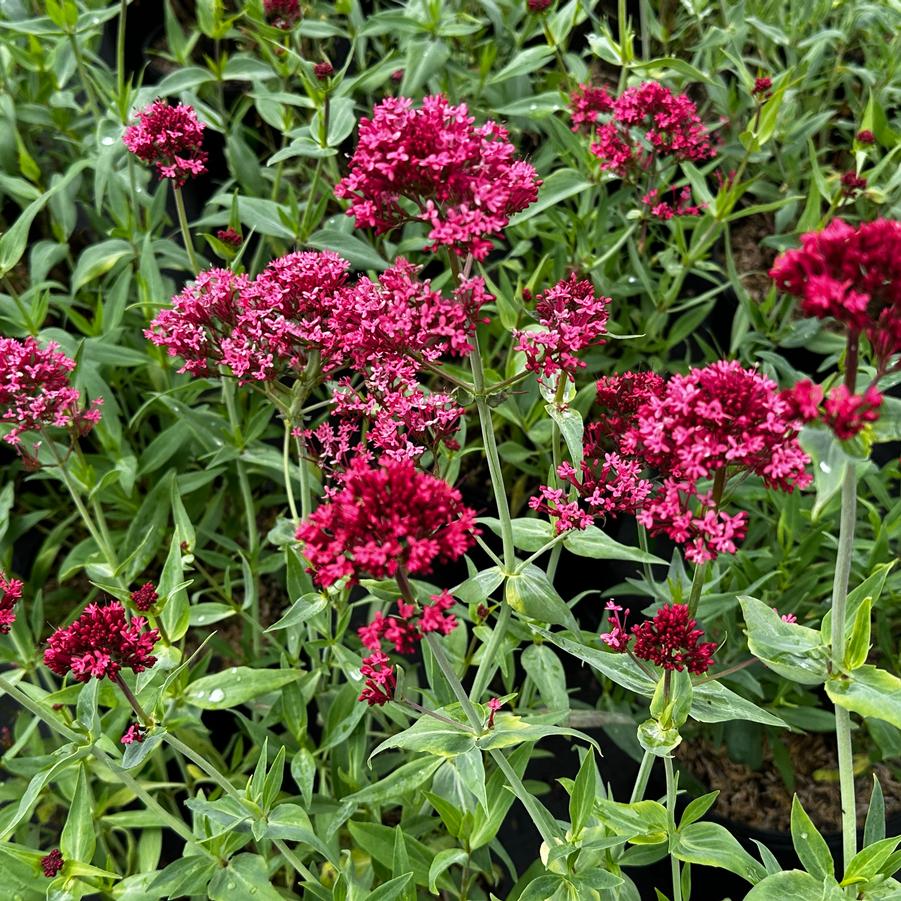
[770,219,901,367]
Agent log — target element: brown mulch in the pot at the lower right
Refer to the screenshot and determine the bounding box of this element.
[676,734,901,832]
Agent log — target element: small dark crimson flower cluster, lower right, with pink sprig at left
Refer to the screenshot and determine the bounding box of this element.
[601,601,716,676]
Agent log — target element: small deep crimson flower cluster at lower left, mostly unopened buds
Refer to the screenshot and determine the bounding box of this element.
[44,601,160,682]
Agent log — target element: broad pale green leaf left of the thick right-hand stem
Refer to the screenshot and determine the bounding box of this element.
[738,596,829,685]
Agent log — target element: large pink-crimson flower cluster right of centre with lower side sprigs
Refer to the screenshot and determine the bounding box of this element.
[530,360,811,563]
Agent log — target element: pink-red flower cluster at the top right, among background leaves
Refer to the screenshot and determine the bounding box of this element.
[572,81,716,178]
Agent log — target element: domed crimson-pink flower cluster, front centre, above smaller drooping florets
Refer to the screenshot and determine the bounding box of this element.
[297,458,475,587]
